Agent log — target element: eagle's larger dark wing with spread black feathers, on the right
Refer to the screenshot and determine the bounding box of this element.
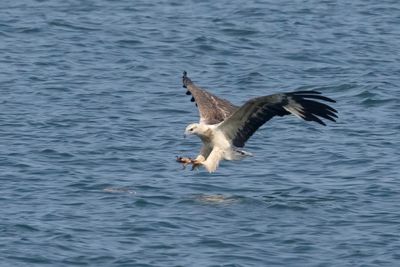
[218,91,337,147]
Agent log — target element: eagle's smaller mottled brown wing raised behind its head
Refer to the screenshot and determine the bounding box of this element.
[182,71,238,124]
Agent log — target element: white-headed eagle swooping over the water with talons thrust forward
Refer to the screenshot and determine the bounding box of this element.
[177,71,338,173]
